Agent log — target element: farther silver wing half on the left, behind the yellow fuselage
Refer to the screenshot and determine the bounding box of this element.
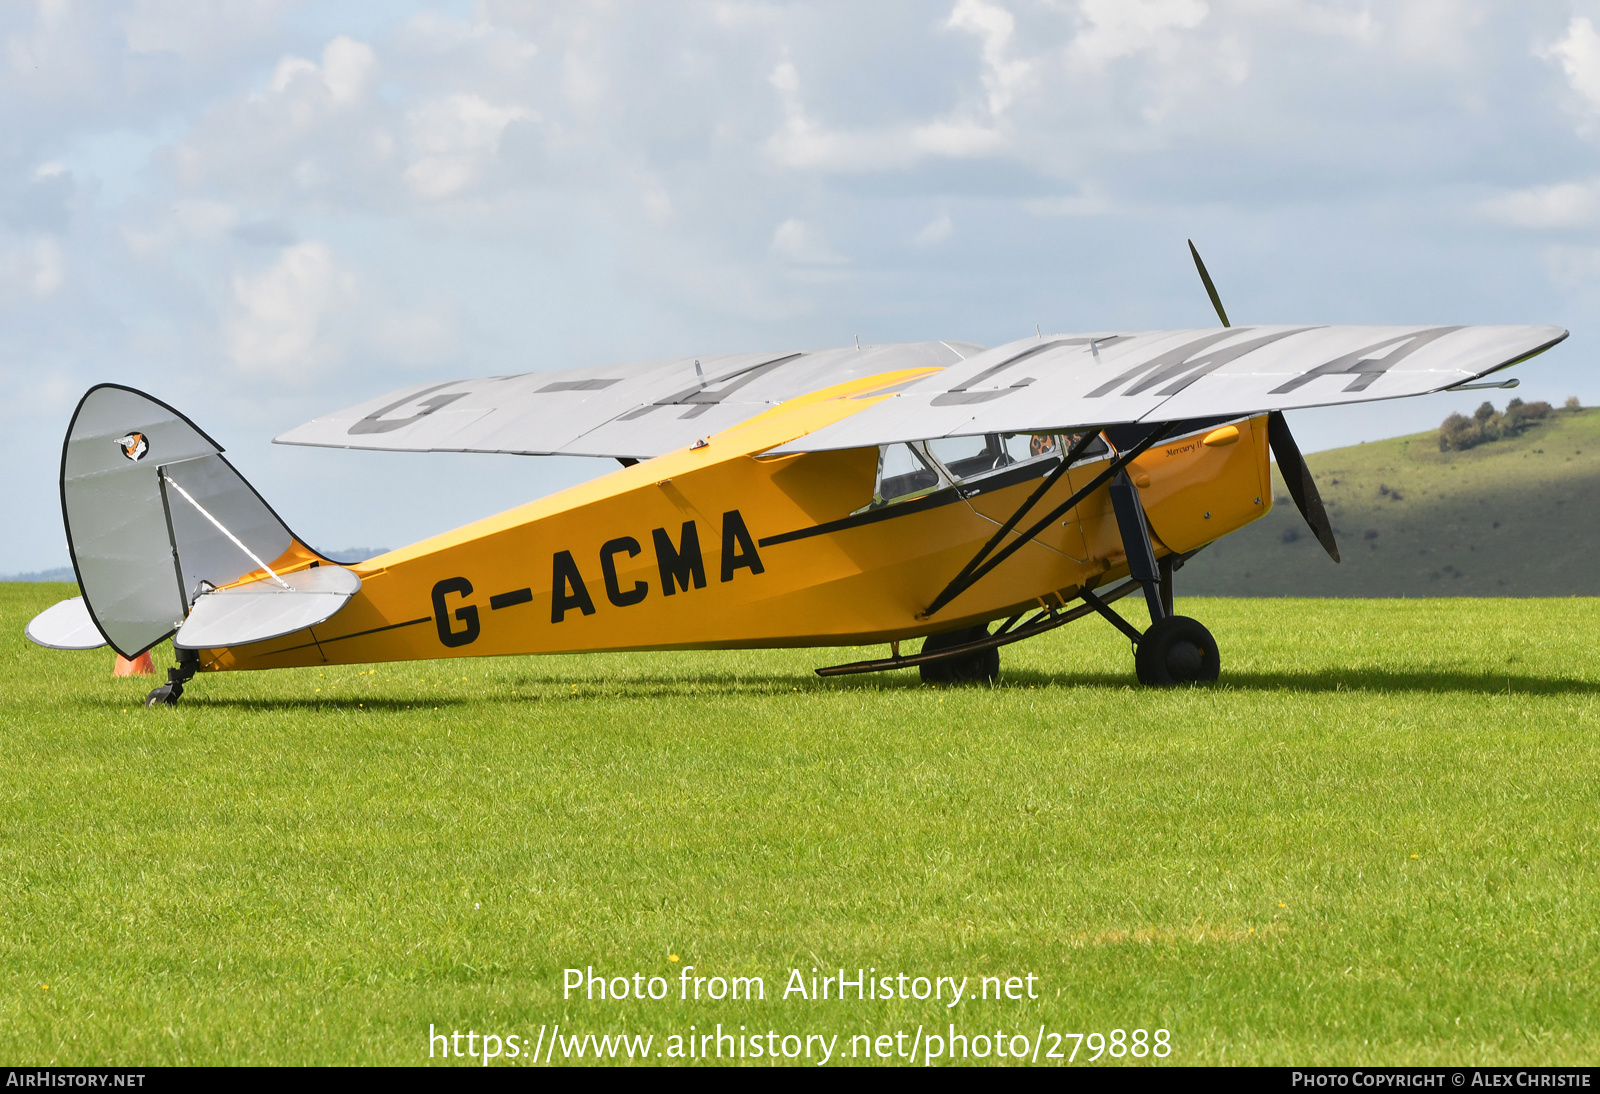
[277,342,982,459]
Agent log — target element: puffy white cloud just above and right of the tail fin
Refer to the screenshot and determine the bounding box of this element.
[222,242,355,381]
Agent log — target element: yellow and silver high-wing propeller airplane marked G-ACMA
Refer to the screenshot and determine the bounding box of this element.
[26,242,1566,707]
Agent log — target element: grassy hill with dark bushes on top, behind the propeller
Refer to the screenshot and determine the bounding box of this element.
[1179,409,1600,597]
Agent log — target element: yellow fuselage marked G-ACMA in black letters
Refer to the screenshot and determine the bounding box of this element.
[209,371,1272,670]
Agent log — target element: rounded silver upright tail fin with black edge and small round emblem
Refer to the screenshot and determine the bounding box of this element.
[61,384,360,657]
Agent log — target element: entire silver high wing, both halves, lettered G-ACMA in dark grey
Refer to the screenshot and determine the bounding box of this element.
[277,326,1566,459]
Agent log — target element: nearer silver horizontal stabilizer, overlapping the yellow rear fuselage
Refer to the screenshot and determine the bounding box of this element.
[173,566,362,649]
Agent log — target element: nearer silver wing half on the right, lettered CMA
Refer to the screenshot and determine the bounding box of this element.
[771,326,1566,453]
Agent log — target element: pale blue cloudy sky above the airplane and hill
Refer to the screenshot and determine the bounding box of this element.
[0,0,1600,573]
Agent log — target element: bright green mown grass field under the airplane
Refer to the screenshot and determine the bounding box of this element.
[0,585,1600,1064]
